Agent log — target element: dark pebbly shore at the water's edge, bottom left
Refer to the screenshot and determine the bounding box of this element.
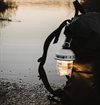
[0,78,61,105]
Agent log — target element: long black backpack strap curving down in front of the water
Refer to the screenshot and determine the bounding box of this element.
[38,19,70,100]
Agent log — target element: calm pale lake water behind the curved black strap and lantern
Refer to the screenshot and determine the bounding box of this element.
[0,6,72,84]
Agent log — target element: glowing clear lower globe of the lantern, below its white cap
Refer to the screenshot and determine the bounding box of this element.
[57,60,73,76]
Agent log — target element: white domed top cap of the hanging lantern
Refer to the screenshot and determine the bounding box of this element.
[55,49,75,61]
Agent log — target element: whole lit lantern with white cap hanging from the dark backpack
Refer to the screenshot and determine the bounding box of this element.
[55,49,75,76]
